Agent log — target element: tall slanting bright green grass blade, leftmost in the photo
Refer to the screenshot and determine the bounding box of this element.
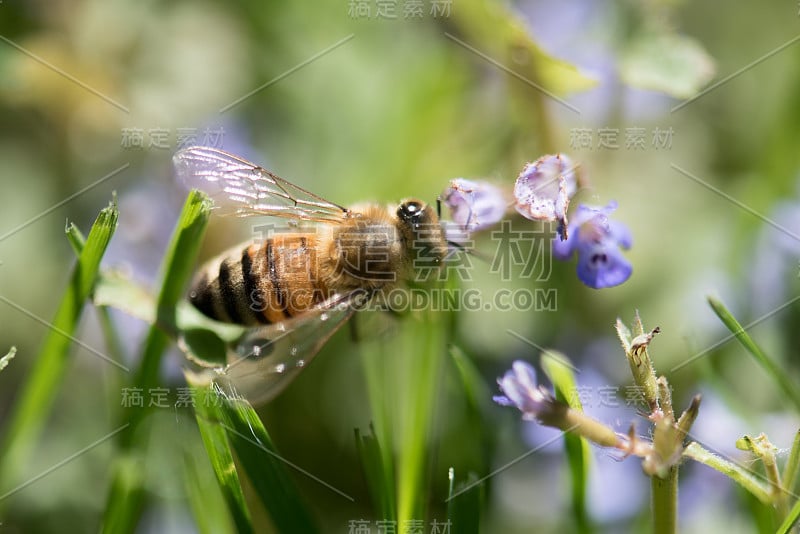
[0,199,117,492]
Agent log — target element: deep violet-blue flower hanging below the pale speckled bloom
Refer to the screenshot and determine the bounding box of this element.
[553,201,633,289]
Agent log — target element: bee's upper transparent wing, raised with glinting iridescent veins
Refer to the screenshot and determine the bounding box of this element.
[172,146,349,223]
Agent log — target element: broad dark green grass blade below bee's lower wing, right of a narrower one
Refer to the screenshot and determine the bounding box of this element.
[214,388,318,533]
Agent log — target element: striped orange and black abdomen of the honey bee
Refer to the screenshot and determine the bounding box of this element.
[190,234,327,325]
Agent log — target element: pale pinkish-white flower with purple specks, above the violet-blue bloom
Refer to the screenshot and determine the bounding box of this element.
[514,154,578,240]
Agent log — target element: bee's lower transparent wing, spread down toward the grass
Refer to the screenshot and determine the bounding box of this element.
[221,290,368,404]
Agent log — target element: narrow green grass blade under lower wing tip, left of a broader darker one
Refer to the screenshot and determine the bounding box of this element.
[190,386,253,533]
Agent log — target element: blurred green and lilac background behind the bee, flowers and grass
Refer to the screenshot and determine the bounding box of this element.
[0,0,800,532]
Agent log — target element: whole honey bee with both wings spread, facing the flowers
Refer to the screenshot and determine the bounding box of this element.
[173,146,448,402]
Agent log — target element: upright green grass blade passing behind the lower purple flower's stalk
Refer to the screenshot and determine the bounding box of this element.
[541,351,592,532]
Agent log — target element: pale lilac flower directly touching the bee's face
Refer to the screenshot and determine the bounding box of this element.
[440,178,508,232]
